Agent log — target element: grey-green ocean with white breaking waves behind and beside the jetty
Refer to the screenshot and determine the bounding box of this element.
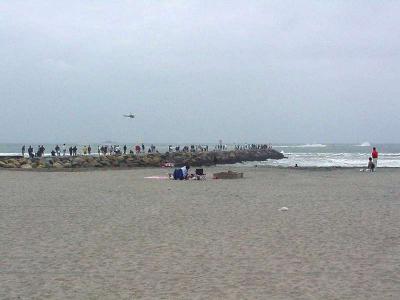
[0,142,400,168]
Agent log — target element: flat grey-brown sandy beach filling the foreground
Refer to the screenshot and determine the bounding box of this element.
[0,168,400,299]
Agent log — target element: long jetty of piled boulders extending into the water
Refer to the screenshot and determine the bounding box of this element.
[0,149,284,170]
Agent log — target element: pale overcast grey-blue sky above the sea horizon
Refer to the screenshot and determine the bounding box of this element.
[0,0,400,143]
